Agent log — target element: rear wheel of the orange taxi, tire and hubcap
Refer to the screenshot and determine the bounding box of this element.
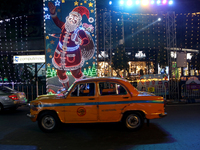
[123,112,144,131]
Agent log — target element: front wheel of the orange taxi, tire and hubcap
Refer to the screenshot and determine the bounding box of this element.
[38,111,60,133]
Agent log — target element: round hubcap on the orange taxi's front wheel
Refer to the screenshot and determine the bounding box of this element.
[42,116,55,130]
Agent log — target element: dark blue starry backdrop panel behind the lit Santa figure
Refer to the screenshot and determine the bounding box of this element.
[43,0,97,92]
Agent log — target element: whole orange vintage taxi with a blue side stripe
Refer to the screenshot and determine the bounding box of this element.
[27,77,167,132]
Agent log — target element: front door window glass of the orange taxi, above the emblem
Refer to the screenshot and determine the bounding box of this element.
[71,83,95,97]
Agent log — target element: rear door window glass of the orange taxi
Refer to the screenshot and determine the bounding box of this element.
[99,82,127,95]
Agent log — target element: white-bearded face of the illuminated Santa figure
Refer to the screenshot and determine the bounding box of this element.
[65,14,81,32]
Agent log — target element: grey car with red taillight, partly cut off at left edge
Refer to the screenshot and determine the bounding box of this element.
[0,86,27,112]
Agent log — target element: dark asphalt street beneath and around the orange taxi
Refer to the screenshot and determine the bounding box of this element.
[0,103,200,150]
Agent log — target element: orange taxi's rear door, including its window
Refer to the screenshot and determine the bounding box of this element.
[98,82,131,121]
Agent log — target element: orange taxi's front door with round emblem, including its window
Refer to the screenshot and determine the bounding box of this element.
[65,82,98,123]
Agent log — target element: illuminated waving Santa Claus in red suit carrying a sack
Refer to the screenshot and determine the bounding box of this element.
[48,2,95,87]
